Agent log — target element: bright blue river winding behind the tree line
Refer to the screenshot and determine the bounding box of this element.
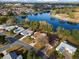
[17,13,79,30]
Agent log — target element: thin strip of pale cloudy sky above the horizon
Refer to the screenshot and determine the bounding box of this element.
[0,0,79,2]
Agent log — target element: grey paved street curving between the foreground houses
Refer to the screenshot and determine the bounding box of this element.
[0,41,47,59]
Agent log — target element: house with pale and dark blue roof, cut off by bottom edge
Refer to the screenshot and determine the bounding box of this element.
[3,52,23,59]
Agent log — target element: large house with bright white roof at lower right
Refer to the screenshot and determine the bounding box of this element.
[56,41,77,54]
